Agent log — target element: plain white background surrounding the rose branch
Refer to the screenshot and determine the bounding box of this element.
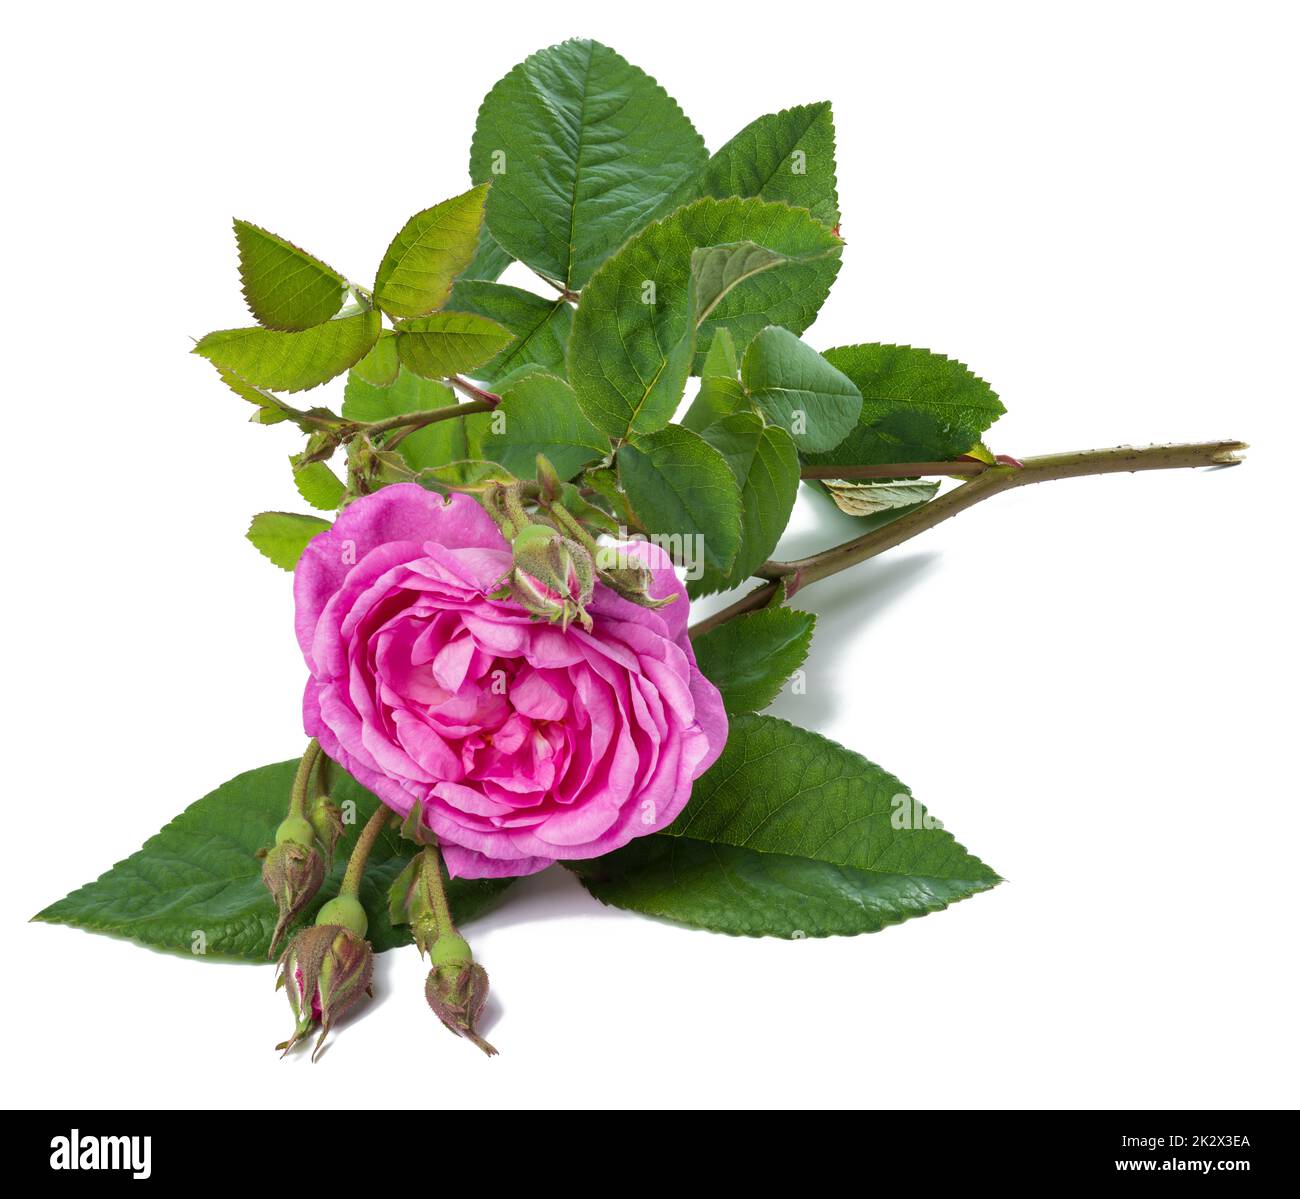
[0,0,1300,1108]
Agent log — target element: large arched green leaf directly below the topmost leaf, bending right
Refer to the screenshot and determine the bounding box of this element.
[568,199,842,437]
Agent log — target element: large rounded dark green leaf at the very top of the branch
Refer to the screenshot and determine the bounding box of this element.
[469,39,706,291]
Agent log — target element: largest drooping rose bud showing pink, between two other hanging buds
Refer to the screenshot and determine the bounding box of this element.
[276,895,374,1061]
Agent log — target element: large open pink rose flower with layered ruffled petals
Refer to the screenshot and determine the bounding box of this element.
[294,484,727,878]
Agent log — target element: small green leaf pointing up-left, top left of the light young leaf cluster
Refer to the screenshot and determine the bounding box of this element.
[235,220,347,330]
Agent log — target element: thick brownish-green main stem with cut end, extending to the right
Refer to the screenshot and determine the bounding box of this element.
[690,441,1245,637]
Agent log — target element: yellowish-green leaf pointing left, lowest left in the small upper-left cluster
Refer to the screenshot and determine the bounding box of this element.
[194,311,380,391]
